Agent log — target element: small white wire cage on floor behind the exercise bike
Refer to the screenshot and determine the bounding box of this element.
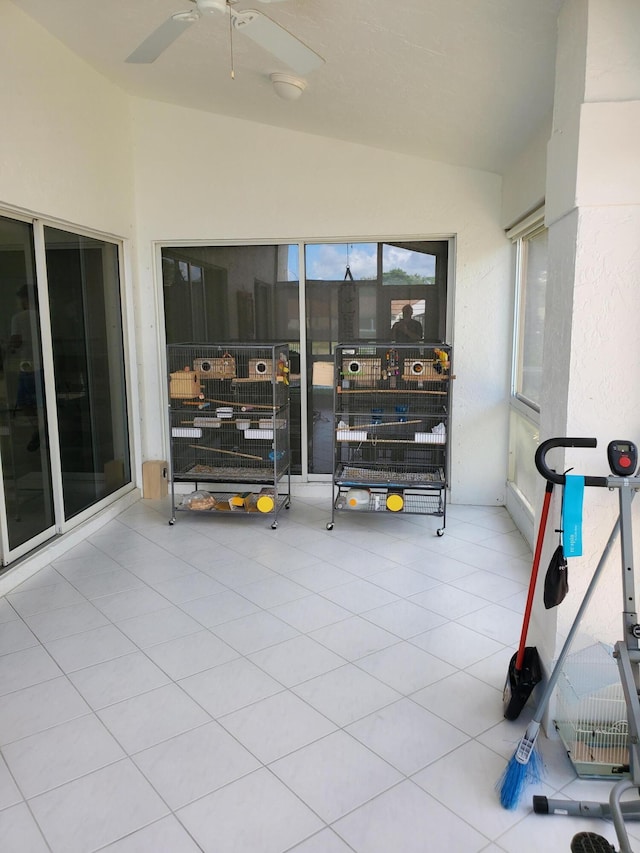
[554,643,629,778]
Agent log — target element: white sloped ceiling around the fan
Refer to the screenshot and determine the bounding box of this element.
[13,0,563,173]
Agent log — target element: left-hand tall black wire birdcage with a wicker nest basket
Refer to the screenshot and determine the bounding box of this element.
[167,343,291,526]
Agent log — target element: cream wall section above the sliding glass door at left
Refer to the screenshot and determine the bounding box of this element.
[0,3,133,237]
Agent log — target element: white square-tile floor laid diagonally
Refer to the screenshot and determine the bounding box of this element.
[0,495,640,853]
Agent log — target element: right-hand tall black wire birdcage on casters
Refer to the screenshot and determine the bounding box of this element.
[327,343,452,535]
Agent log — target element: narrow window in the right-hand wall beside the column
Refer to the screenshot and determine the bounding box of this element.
[507,210,548,520]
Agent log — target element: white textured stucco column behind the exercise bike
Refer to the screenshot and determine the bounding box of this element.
[532,0,640,665]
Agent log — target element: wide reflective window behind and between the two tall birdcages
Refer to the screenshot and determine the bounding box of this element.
[161,240,449,475]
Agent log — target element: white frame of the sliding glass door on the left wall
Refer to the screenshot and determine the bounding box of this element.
[0,206,141,573]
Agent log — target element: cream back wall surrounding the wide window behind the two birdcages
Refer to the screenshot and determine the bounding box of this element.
[133,100,511,504]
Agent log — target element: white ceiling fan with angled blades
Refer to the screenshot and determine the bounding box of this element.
[125,0,324,74]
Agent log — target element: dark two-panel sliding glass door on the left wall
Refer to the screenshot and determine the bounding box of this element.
[0,217,131,565]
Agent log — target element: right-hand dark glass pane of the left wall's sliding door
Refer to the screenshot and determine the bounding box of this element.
[44,227,131,520]
